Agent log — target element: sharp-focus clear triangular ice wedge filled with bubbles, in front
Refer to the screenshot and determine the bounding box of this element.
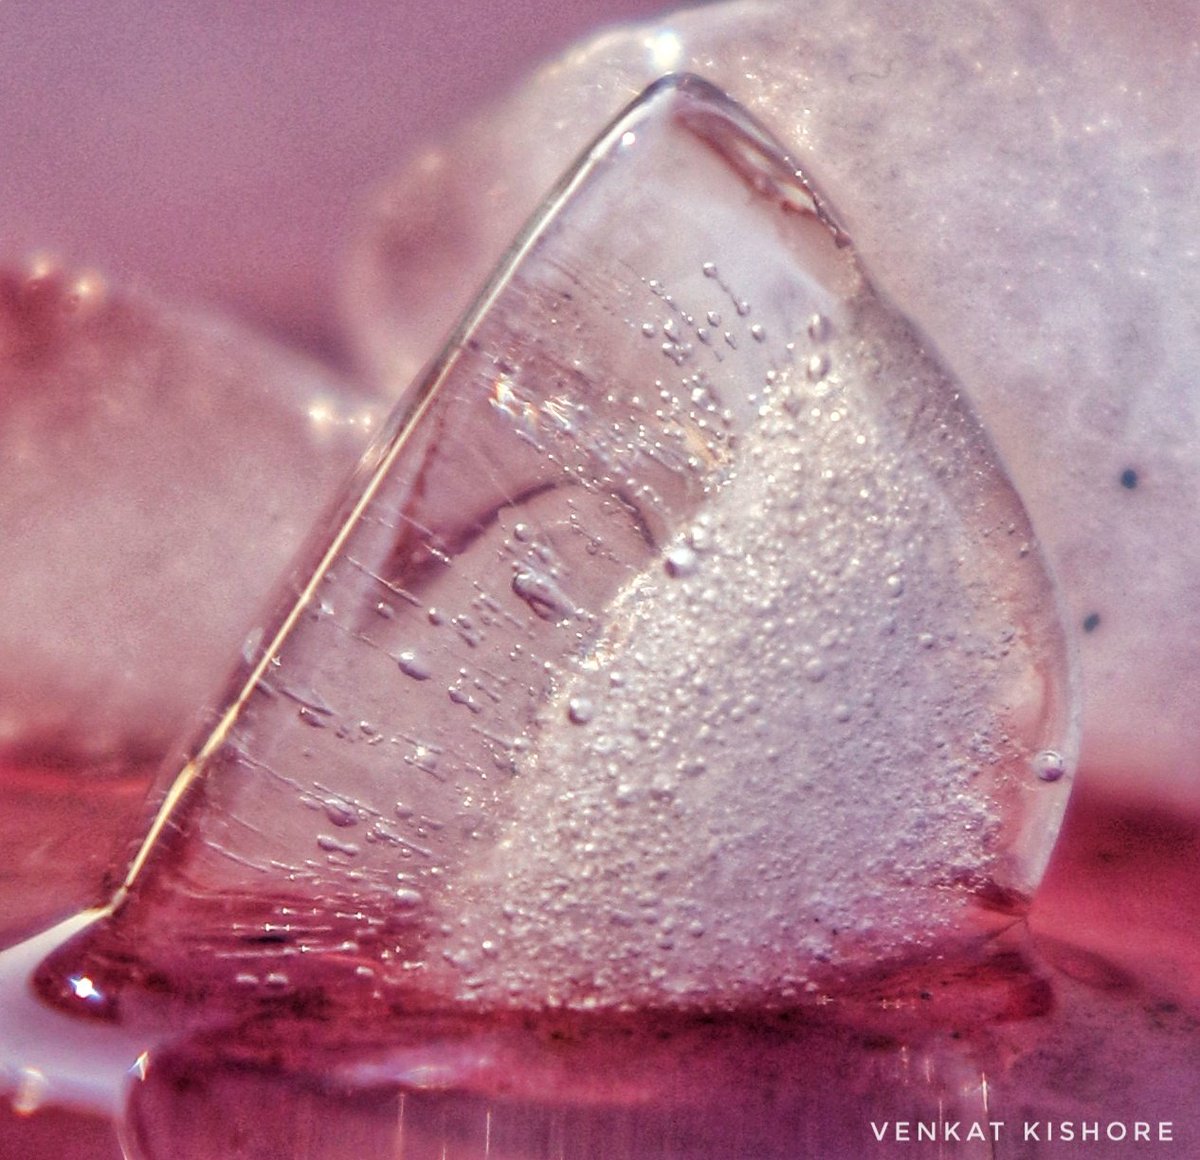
[43,78,1074,1018]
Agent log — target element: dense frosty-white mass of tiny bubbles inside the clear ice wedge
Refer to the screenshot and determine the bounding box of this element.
[408,231,1064,1005]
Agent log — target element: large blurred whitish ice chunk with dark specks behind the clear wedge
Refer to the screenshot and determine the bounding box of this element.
[347,0,1200,825]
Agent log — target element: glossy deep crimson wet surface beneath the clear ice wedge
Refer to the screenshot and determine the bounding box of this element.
[0,767,1200,1158]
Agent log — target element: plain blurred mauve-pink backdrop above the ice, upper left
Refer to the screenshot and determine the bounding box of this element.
[0,0,665,351]
